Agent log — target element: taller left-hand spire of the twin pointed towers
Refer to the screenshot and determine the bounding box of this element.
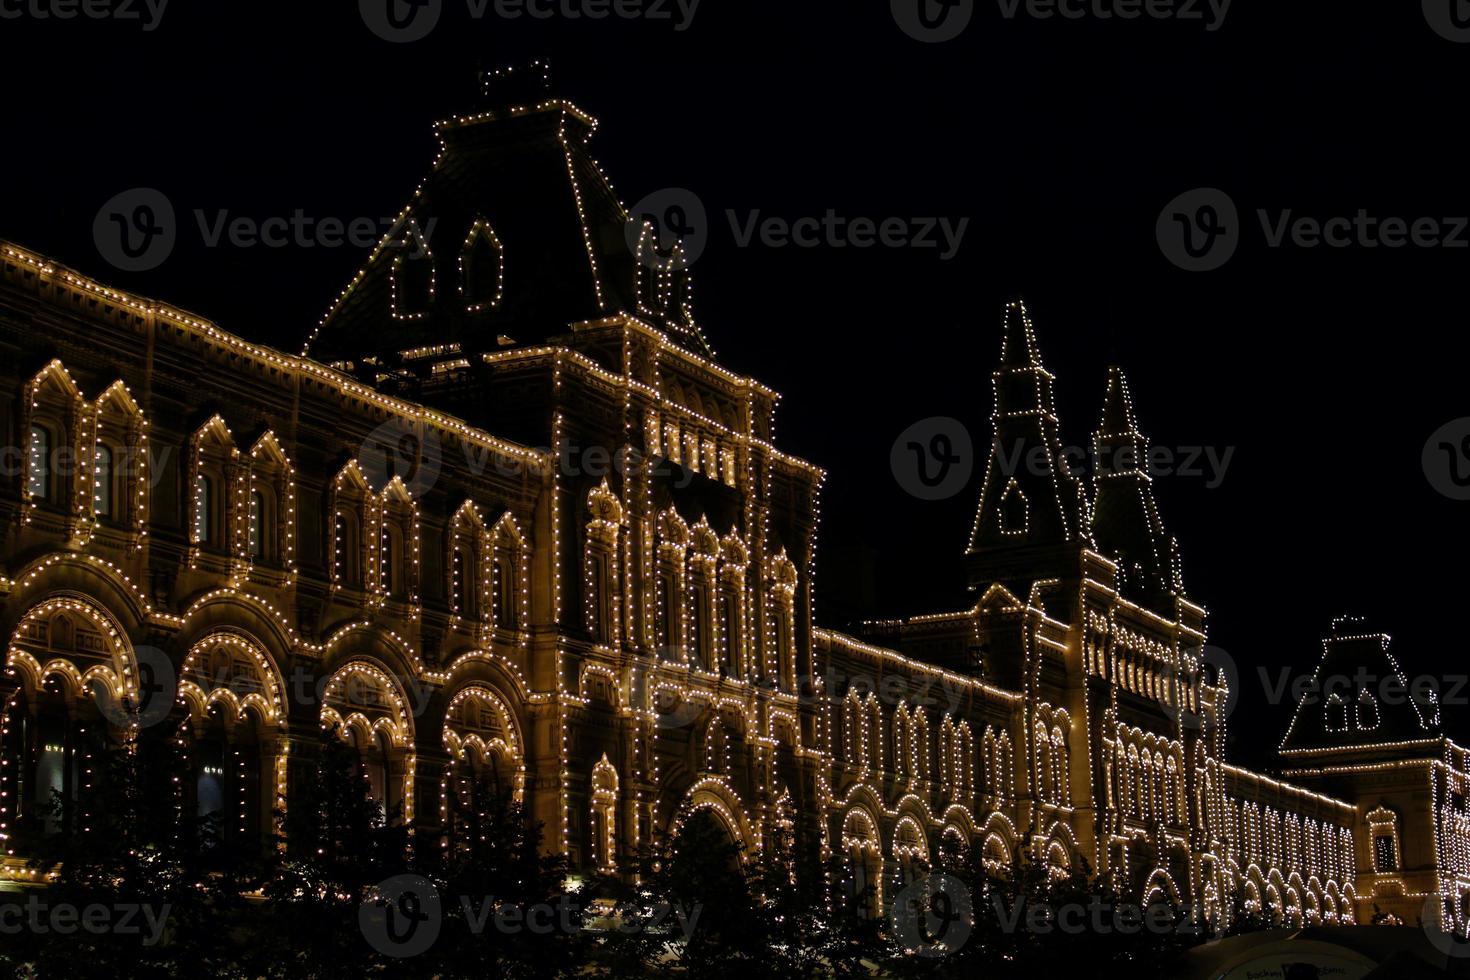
[966,300,1086,588]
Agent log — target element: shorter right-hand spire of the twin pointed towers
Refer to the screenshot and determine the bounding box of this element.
[1092,366,1183,614]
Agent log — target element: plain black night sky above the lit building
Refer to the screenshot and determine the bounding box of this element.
[0,0,1470,749]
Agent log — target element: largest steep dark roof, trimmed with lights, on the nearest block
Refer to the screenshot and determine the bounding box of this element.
[304,63,711,363]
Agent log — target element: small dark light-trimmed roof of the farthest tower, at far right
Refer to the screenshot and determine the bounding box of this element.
[1280,616,1441,755]
